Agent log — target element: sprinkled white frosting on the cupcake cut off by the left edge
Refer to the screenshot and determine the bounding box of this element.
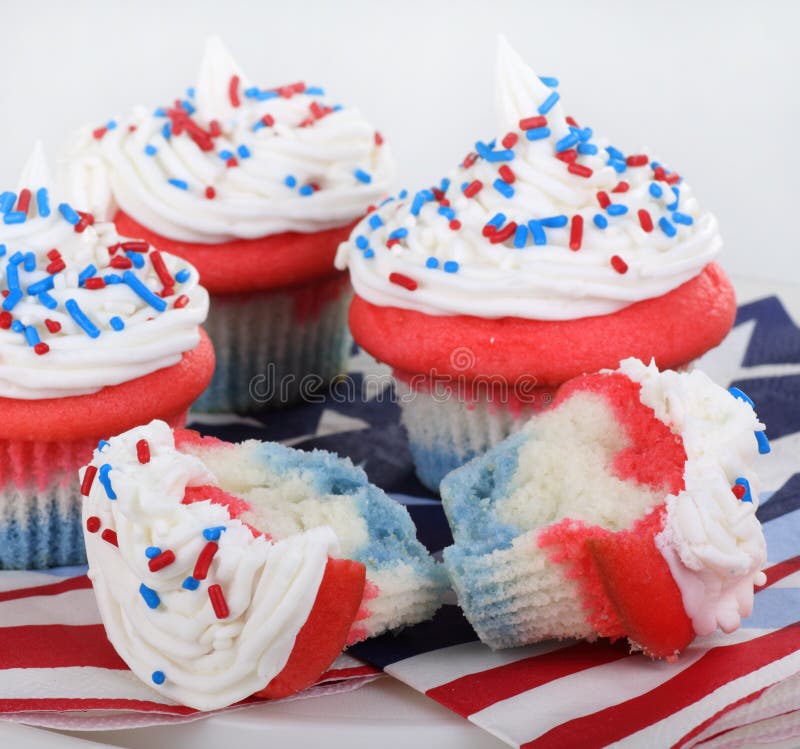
[0,146,208,399]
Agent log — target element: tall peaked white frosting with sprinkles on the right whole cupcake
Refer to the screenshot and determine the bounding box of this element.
[336,39,721,320]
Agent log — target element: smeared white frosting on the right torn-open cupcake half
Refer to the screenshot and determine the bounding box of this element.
[620,359,767,635]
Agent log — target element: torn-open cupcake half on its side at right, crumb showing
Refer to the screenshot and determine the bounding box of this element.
[442,359,769,658]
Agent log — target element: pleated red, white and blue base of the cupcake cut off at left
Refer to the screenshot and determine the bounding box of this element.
[0,413,186,569]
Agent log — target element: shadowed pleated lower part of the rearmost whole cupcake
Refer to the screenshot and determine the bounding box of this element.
[193,276,352,412]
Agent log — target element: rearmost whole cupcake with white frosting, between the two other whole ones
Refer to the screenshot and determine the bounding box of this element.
[62,38,393,411]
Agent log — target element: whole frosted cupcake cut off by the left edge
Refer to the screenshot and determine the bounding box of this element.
[0,146,214,569]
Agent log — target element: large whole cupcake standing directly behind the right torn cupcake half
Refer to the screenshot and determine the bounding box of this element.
[337,39,735,490]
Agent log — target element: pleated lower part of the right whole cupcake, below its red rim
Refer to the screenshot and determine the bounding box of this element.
[397,378,550,491]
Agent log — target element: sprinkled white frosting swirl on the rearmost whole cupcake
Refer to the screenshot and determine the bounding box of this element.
[61,38,394,244]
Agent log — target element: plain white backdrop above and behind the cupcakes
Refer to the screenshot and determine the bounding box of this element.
[0,0,800,282]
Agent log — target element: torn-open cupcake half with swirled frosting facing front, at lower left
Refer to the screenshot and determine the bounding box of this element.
[82,421,446,710]
